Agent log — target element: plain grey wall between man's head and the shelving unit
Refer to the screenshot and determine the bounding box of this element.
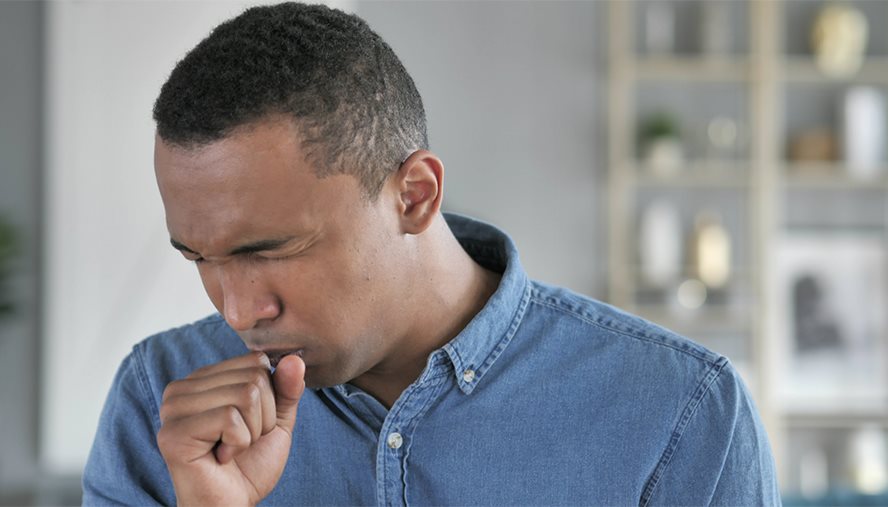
[356,1,607,297]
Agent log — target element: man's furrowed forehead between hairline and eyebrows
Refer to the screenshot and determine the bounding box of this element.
[155,120,360,253]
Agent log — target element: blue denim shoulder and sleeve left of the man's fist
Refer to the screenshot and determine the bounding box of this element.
[83,315,238,505]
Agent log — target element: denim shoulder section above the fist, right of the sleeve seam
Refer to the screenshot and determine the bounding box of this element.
[127,314,247,401]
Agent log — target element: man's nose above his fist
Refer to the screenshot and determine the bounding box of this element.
[220,263,281,331]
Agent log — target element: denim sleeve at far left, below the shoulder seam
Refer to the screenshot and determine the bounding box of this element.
[83,348,175,505]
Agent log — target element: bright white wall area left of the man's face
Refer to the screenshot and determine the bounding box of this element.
[41,1,352,474]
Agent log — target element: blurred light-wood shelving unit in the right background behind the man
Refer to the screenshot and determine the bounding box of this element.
[608,0,888,504]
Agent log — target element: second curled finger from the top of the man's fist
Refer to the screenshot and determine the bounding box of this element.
[160,376,276,442]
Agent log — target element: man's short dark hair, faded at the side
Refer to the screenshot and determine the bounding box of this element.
[154,2,428,200]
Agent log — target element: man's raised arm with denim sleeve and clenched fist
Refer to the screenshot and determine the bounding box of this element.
[83,347,304,505]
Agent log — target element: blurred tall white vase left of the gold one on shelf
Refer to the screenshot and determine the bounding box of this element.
[638,199,682,289]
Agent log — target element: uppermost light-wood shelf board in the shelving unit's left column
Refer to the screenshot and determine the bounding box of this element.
[634,55,750,83]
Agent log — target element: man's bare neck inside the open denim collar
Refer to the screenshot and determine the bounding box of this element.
[351,215,500,408]
